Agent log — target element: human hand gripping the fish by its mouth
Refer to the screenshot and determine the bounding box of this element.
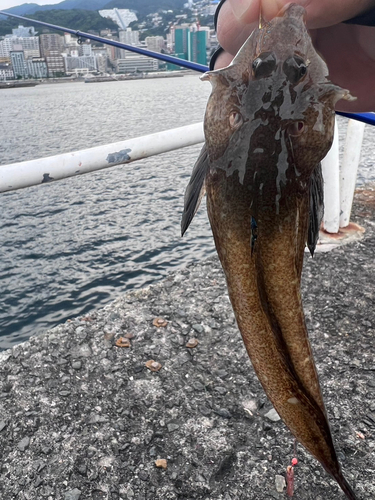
[215,0,375,112]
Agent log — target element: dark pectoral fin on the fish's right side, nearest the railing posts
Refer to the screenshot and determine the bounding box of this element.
[307,163,324,257]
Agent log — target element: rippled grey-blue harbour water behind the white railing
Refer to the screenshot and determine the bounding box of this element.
[0,76,375,349]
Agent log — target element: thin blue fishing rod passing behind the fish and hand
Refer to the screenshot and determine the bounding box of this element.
[0,10,375,125]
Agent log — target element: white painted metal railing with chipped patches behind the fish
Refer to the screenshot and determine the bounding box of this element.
[0,120,365,233]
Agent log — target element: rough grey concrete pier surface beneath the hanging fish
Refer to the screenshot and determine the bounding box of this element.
[0,189,375,500]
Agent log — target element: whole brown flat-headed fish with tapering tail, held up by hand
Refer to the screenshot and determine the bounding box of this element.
[181,4,357,500]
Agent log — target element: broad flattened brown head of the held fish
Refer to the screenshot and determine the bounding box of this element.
[202,4,353,185]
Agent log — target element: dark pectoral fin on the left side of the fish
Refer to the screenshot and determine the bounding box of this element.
[181,144,209,236]
